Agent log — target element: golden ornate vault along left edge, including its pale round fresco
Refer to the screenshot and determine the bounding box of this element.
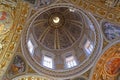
[0,0,29,80]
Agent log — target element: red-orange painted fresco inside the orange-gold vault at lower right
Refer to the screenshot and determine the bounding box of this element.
[105,58,120,75]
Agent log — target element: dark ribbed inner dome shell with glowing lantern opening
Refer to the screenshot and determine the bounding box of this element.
[31,7,84,50]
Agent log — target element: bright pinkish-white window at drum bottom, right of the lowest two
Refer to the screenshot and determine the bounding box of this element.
[65,56,77,68]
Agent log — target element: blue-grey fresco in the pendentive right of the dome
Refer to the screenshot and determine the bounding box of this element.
[102,22,120,41]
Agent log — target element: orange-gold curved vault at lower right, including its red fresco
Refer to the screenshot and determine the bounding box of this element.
[91,43,120,80]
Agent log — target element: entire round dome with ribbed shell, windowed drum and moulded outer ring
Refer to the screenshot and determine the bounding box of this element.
[21,3,102,79]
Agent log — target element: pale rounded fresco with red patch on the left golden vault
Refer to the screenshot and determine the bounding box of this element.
[0,11,13,34]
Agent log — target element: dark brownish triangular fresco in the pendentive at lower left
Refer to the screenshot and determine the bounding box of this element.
[8,55,26,77]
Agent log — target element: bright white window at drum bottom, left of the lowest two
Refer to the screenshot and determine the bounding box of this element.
[43,56,53,68]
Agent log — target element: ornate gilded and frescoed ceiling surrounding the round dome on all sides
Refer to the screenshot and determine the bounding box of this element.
[0,0,120,80]
